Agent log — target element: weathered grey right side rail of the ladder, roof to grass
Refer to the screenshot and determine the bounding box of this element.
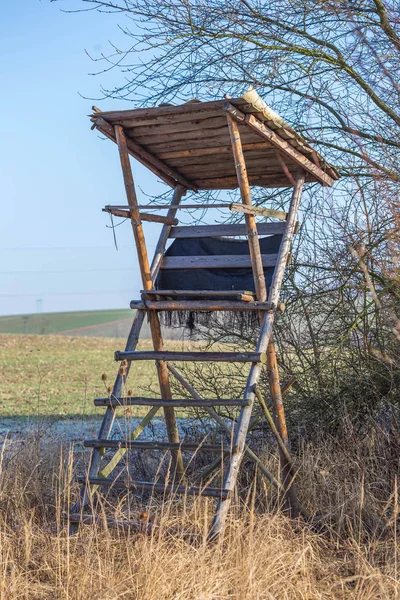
[209,167,305,539]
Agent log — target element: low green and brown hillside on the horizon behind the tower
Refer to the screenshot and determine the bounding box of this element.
[0,309,180,339]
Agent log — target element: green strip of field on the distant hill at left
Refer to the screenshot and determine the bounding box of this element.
[0,309,133,335]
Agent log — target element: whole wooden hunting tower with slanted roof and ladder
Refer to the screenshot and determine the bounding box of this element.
[69,90,338,538]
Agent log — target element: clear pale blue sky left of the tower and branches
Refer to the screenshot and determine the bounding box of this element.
[0,0,173,315]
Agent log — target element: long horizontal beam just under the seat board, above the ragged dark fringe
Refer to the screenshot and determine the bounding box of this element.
[130,300,274,312]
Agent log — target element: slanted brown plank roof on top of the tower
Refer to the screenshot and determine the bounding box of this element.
[91,98,339,191]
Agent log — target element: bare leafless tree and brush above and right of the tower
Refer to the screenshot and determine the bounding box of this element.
[63,0,400,428]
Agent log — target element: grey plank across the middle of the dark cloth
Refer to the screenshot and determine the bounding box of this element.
[161,254,278,270]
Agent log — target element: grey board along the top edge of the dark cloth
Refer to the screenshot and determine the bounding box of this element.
[169,223,286,238]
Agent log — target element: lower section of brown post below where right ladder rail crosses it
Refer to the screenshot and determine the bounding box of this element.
[267,342,299,518]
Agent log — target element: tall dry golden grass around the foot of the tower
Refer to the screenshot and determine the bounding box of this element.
[0,430,400,600]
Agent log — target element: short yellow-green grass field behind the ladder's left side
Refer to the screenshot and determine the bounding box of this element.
[0,334,191,416]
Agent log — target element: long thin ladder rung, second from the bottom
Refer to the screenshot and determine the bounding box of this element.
[76,476,229,498]
